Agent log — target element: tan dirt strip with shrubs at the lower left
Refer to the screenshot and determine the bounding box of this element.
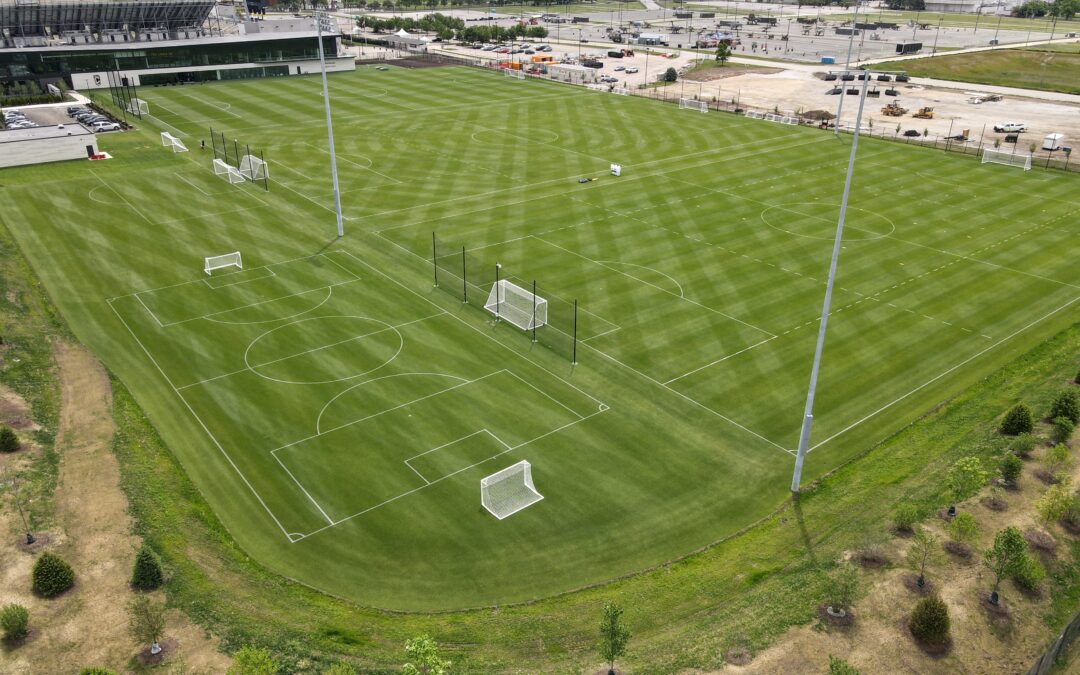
[0,343,228,673]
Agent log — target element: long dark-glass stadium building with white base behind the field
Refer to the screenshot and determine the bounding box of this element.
[0,0,355,91]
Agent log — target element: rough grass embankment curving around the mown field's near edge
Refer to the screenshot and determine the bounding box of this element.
[113,298,1080,673]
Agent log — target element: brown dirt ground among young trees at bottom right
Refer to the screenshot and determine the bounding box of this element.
[720,441,1080,675]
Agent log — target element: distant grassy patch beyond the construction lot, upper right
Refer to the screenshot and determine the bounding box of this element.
[881,49,1080,94]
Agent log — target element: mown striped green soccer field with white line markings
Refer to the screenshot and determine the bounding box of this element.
[0,68,1080,610]
